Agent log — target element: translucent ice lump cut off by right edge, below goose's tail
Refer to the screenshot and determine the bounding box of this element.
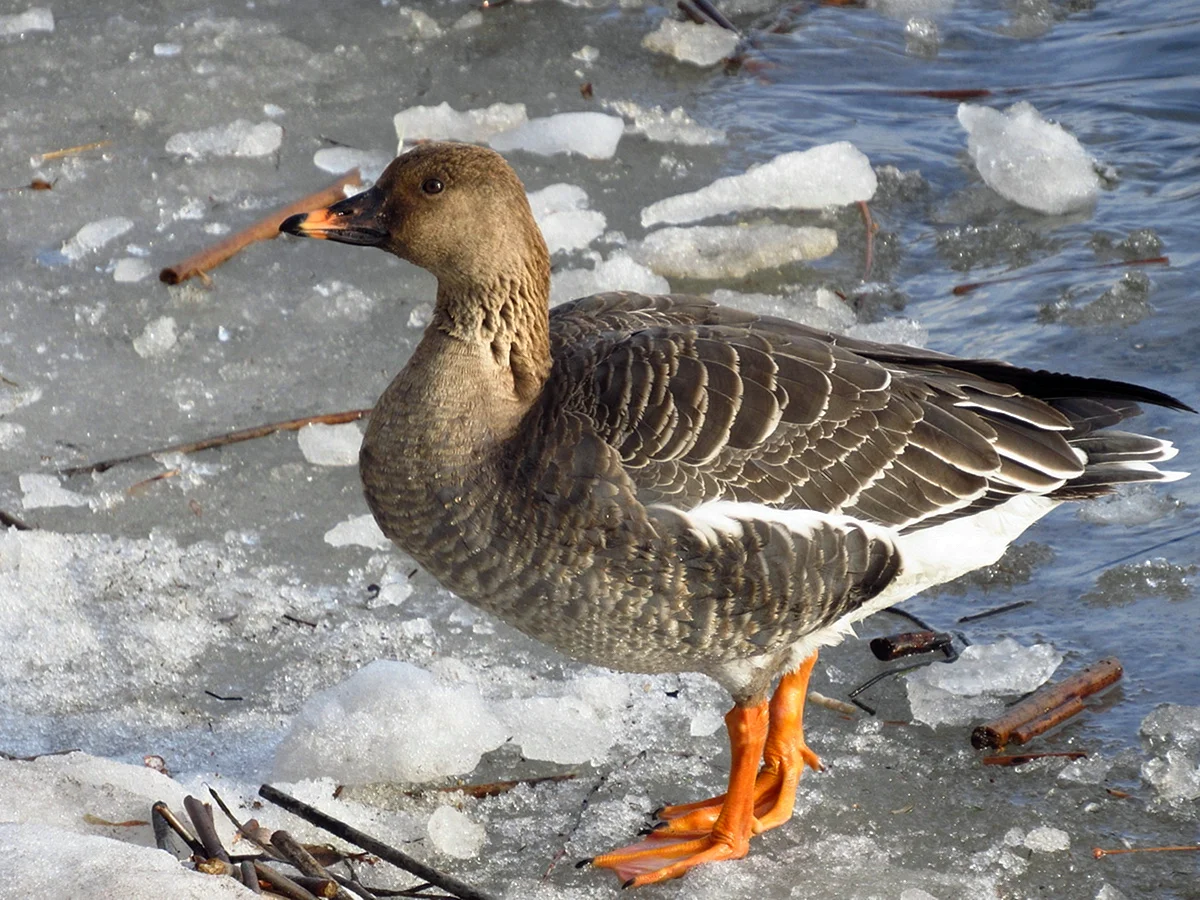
[1141,703,1200,816]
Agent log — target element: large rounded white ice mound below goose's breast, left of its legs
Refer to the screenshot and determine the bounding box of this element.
[275,660,508,785]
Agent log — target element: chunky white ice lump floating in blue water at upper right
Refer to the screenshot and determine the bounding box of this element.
[959,101,1100,215]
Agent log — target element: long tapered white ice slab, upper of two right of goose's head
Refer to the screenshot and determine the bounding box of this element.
[642,140,878,228]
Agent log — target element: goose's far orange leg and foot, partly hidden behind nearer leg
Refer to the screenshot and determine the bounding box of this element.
[656,653,823,836]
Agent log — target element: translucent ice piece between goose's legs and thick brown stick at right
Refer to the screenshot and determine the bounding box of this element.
[907,637,1062,727]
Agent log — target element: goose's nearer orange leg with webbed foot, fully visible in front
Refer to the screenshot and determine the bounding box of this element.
[592,703,768,887]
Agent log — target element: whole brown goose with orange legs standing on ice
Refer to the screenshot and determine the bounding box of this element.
[282,144,1187,883]
